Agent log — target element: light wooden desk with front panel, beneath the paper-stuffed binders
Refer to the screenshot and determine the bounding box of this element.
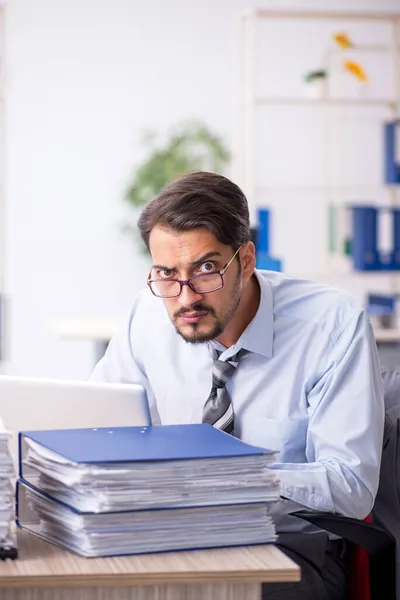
[0,531,300,600]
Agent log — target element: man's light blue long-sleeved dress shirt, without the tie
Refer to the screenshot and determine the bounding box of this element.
[92,271,384,532]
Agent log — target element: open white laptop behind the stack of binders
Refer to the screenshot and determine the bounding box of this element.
[0,375,151,466]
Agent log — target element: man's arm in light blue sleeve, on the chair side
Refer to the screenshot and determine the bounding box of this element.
[274,311,384,519]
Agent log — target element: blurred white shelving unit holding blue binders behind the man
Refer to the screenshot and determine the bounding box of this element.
[232,9,400,332]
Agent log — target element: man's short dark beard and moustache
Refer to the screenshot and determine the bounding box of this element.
[172,276,241,344]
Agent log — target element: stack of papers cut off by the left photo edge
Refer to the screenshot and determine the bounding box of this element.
[0,419,17,559]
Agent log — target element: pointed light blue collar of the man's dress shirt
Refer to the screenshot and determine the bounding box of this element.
[211,269,274,358]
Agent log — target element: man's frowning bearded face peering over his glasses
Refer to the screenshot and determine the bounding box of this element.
[150,227,242,343]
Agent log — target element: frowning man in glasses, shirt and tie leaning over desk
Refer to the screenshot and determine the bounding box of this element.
[93,172,384,600]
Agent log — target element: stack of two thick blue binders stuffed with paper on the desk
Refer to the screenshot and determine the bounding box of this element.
[17,425,279,556]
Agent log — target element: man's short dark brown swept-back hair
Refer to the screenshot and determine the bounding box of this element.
[138,171,250,250]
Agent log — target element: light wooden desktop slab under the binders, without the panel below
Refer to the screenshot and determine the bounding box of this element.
[0,530,300,589]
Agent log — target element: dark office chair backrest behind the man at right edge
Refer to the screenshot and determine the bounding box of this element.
[371,369,400,600]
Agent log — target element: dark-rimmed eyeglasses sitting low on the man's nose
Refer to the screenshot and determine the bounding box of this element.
[147,246,241,298]
